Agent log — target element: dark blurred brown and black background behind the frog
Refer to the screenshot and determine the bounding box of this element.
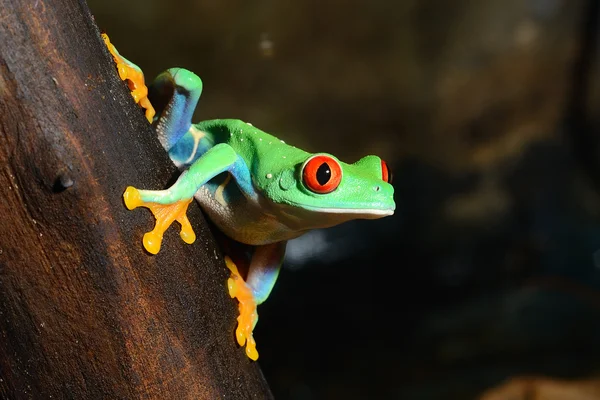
[88,0,600,400]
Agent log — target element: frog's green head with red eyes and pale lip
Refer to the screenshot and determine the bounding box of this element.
[263,153,396,228]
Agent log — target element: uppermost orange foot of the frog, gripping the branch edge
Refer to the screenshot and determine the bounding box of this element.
[102,33,156,123]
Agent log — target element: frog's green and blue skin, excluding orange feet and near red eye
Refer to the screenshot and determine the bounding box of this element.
[123,68,395,356]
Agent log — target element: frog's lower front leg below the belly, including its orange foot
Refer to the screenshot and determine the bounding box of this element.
[225,241,287,360]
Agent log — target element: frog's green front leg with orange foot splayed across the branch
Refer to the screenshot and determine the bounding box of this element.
[123,143,251,254]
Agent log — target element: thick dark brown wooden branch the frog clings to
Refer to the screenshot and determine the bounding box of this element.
[0,0,271,399]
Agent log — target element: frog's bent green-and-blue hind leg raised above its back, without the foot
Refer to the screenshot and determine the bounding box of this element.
[149,68,202,151]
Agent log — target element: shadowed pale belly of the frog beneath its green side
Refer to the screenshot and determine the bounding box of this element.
[194,182,304,246]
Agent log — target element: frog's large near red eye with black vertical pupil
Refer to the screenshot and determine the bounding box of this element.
[302,155,342,194]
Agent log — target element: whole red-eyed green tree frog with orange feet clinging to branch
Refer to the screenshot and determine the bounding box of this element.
[103,35,396,360]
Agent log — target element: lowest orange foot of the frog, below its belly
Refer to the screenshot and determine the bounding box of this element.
[225,256,258,361]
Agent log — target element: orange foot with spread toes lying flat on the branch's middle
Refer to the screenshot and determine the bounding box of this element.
[123,186,196,254]
